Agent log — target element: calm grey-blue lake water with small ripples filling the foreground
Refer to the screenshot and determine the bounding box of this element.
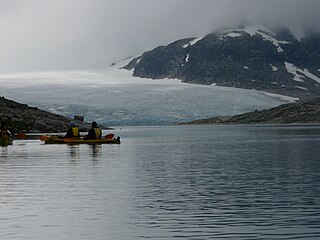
[0,126,320,240]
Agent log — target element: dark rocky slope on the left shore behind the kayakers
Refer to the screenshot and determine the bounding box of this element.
[0,97,90,132]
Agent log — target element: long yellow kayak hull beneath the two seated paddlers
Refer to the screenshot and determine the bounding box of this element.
[40,134,121,144]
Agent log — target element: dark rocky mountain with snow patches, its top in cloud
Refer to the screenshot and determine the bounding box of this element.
[123,27,320,98]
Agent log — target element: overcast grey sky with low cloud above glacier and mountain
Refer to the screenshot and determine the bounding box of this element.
[0,0,320,73]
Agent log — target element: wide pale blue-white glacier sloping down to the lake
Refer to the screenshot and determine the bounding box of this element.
[0,64,296,126]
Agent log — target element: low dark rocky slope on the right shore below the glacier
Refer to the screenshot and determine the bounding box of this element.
[184,98,320,124]
